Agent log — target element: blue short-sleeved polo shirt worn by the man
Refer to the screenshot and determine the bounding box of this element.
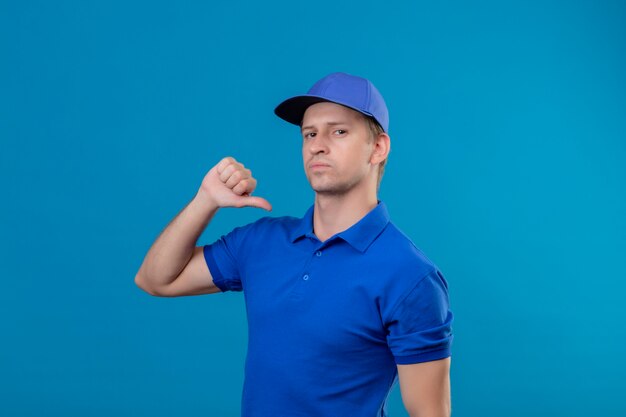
[204,200,453,417]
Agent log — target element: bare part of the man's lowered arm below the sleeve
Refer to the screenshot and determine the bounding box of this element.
[397,357,452,417]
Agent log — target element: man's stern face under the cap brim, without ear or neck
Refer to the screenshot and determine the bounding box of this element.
[302,102,376,195]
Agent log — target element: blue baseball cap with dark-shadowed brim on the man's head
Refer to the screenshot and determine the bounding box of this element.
[274,72,389,132]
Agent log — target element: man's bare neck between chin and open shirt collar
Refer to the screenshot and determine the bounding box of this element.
[313,182,378,242]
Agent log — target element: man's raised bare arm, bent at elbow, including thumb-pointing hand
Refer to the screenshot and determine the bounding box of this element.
[135,157,272,297]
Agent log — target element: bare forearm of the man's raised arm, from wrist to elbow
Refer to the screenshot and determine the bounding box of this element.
[136,190,218,288]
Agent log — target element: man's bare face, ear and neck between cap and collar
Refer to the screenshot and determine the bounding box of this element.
[301,102,391,242]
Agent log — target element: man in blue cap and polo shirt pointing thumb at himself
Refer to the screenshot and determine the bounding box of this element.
[135,73,453,417]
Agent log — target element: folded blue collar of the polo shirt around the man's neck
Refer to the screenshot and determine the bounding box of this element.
[291,200,389,252]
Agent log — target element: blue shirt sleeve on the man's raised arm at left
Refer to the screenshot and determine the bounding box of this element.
[203,225,251,292]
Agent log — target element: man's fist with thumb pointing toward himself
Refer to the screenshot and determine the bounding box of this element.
[198,156,272,211]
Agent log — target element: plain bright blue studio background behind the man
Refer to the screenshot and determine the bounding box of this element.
[0,0,626,417]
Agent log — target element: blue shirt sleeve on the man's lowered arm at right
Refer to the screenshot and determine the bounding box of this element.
[386,269,453,365]
